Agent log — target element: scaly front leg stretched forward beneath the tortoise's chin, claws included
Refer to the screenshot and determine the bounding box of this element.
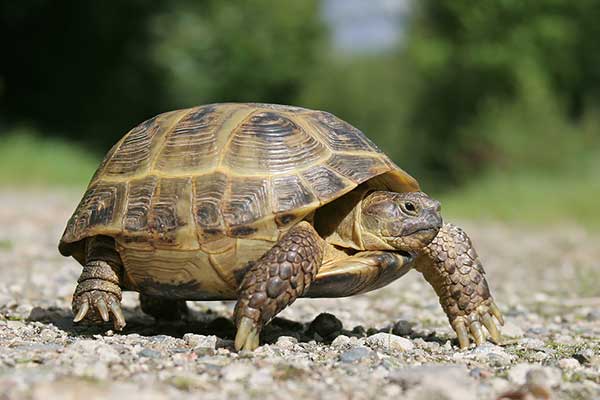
[415,224,504,349]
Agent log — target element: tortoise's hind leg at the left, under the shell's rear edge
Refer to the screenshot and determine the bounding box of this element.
[72,236,125,331]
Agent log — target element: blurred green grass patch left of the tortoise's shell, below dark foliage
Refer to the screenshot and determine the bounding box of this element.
[0,129,100,188]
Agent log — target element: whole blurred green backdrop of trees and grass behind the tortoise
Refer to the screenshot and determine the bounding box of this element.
[0,0,600,228]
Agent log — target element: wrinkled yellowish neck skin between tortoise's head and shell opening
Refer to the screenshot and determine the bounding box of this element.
[324,190,397,251]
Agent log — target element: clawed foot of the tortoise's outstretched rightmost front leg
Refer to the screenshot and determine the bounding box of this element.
[450,298,504,349]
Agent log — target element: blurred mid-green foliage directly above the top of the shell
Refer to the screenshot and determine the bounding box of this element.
[152,0,326,108]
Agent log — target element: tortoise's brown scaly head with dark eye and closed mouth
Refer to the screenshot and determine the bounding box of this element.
[361,191,442,254]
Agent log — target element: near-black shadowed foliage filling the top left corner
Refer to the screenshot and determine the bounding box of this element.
[0,0,164,149]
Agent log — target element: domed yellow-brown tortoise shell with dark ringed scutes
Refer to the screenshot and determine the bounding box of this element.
[59,103,418,258]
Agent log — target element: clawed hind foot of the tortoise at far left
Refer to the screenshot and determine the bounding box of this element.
[72,290,126,331]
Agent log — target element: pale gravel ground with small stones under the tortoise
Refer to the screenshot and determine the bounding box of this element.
[0,191,600,400]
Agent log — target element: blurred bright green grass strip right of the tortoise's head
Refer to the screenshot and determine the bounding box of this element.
[441,158,600,230]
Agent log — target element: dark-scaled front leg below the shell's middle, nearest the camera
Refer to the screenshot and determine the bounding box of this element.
[234,222,324,350]
